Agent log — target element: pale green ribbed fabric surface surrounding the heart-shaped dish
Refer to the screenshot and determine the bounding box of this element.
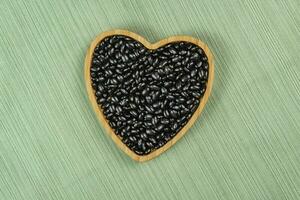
[0,0,300,200]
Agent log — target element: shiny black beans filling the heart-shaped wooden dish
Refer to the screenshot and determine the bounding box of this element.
[90,35,209,155]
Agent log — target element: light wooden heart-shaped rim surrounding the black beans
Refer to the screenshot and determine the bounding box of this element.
[84,29,214,162]
